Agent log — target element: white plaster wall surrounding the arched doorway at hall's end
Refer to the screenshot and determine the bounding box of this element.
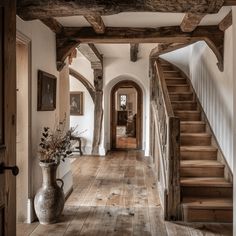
[101,57,150,156]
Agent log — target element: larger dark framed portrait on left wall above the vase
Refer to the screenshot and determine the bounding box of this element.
[38,70,57,111]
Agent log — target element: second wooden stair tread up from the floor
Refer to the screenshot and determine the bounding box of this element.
[180,177,233,188]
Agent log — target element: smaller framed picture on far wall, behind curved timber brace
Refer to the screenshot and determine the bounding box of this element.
[70,92,84,116]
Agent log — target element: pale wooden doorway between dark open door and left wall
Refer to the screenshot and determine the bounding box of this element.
[16,33,31,223]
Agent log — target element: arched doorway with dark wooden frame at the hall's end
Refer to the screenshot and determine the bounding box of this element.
[110,80,143,149]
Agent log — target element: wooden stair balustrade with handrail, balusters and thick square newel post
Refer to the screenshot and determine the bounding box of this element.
[151,60,180,220]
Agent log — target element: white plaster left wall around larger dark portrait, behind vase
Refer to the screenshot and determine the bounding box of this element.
[17,17,72,220]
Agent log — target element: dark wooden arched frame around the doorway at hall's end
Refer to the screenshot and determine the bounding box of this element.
[110,80,143,150]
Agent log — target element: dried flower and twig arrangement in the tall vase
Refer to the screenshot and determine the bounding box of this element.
[39,119,74,163]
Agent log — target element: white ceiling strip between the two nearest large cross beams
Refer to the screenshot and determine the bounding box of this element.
[56,7,231,28]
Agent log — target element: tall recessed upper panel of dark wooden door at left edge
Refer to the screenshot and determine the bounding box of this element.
[0,7,4,149]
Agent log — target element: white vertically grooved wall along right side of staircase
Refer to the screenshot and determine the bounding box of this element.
[190,35,233,170]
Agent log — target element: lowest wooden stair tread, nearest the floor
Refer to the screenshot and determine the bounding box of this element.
[182,197,233,210]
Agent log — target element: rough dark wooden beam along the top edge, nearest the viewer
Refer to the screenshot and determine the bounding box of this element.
[17,0,227,20]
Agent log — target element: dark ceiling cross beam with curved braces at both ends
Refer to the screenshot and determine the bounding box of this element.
[57,26,224,71]
